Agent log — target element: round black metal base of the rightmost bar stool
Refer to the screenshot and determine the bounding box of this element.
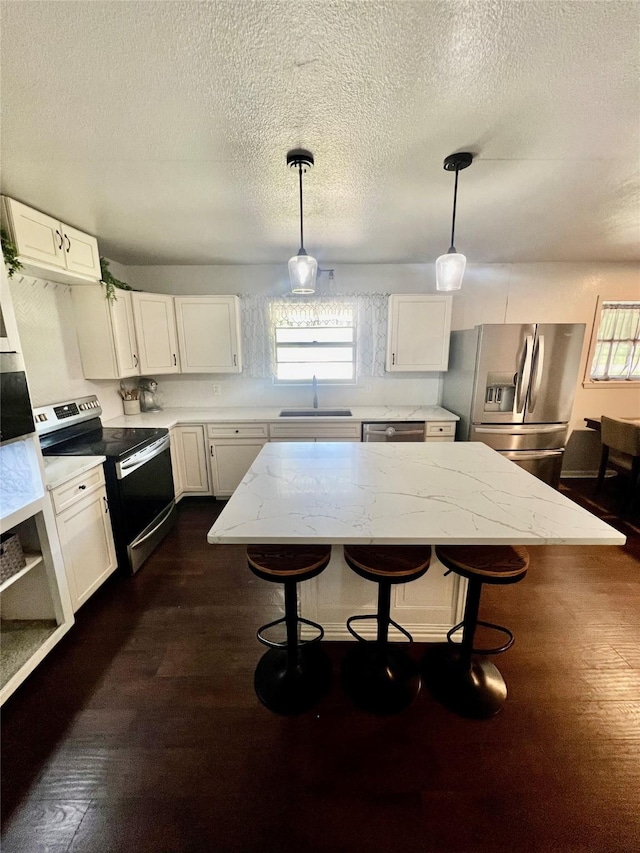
[423,643,507,720]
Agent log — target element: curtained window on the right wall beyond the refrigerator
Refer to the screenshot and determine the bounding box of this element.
[589,302,640,382]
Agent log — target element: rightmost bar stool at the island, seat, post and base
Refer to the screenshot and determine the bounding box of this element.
[424,545,529,719]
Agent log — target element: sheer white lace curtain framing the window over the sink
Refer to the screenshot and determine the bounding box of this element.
[240,293,389,379]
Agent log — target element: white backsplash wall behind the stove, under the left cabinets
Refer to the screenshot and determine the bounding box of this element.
[10,273,122,420]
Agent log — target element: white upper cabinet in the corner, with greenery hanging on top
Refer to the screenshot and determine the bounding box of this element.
[71,284,140,379]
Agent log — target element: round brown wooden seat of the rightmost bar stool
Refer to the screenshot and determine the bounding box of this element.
[436,545,529,584]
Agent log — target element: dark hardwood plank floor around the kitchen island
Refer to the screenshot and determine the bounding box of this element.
[2,481,640,853]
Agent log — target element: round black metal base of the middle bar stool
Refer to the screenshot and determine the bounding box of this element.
[342,642,422,714]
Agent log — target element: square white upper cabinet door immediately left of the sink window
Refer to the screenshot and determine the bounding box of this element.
[174,296,242,373]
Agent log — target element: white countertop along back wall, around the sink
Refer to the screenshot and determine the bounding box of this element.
[105,406,459,429]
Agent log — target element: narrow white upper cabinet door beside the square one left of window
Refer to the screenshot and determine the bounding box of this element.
[131,293,180,376]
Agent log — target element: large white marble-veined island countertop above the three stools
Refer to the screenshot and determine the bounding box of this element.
[207,442,625,545]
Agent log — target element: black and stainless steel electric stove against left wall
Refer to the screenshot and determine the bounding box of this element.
[33,396,176,572]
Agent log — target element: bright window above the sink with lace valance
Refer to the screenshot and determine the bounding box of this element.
[273,302,356,383]
